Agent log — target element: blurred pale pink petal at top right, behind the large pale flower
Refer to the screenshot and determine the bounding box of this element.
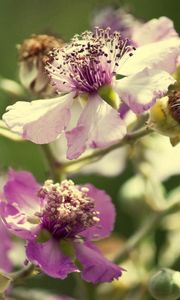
[132,17,178,46]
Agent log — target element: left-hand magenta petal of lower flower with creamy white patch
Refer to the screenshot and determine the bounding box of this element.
[0,170,40,239]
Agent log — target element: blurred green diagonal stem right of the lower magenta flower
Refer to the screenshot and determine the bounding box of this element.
[114,199,180,263]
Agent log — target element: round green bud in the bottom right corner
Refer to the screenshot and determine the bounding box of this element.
[149,269,180,300]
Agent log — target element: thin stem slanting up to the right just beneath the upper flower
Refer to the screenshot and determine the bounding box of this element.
[60,127,153,172]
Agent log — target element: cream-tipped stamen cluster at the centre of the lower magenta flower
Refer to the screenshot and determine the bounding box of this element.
[38,180,99,238]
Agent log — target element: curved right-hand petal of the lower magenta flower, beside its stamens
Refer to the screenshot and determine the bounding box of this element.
[81,184,115,240]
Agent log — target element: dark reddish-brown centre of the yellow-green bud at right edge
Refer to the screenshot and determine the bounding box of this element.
[168,91,180,123]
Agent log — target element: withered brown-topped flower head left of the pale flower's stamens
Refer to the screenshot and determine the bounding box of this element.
[18,34,63,97]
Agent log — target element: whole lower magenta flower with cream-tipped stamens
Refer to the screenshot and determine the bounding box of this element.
[1,170,123,283]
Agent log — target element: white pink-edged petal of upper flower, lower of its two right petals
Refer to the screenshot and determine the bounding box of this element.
[116,68,175,114]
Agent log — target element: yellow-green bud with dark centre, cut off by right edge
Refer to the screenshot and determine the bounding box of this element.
[149,91,180,144]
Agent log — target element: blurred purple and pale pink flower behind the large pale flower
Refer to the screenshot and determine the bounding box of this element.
[91,7,178,47]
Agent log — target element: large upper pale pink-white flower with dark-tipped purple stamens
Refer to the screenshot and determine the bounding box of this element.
[3,28,180,159]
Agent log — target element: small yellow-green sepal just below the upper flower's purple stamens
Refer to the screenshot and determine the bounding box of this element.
[98,85,119,109]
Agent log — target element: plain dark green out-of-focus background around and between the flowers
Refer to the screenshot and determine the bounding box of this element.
[0,0,180,295]
